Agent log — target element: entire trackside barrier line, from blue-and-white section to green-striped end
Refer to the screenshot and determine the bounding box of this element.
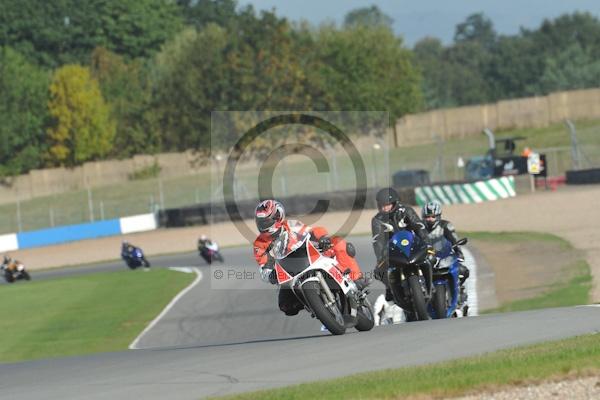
[0,177,516,252]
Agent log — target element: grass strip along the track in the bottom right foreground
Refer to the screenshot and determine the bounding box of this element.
[216,334,600,400]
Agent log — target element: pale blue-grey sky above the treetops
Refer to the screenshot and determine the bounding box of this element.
[238,0,600,47]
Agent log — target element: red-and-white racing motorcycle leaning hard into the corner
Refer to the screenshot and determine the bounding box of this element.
[271,232,374,335]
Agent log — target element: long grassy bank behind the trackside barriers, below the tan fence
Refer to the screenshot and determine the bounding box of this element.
[0,117,600,233]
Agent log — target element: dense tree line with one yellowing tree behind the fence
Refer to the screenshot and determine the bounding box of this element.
[0,0,600,176]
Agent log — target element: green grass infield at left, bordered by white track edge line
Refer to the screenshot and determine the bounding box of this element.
[0,269,194,362]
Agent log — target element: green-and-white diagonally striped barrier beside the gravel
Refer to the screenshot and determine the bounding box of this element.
[415,176,517,205]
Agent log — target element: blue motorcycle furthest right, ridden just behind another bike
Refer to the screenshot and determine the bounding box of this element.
[429,238,467,319]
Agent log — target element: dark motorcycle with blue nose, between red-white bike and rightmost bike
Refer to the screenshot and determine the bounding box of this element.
[384,223,432,321]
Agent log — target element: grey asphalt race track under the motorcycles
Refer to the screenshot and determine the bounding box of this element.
[0,237,600,399]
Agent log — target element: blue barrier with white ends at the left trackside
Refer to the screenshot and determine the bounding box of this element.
[0,214,157,252]
